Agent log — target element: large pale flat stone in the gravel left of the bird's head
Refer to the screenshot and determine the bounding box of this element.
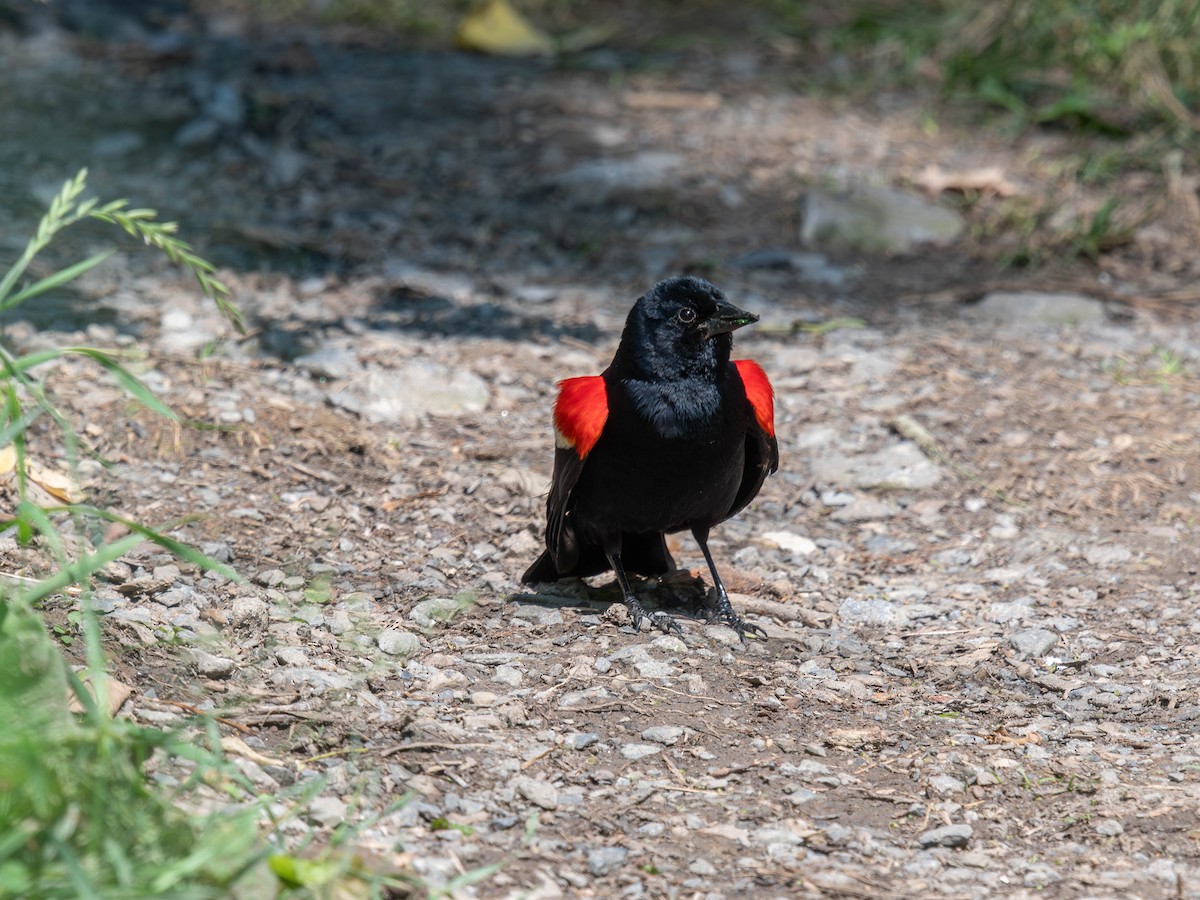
[329,360,491,426]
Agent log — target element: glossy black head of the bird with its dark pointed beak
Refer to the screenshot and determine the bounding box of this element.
[614,275,758,379]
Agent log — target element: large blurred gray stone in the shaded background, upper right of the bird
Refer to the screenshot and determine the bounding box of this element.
[800,186,962,253]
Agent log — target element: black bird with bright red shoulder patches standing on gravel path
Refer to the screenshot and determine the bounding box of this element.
[522,276,779,640]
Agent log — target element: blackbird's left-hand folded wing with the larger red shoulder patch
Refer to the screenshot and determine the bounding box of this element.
[546,376,608,572]
